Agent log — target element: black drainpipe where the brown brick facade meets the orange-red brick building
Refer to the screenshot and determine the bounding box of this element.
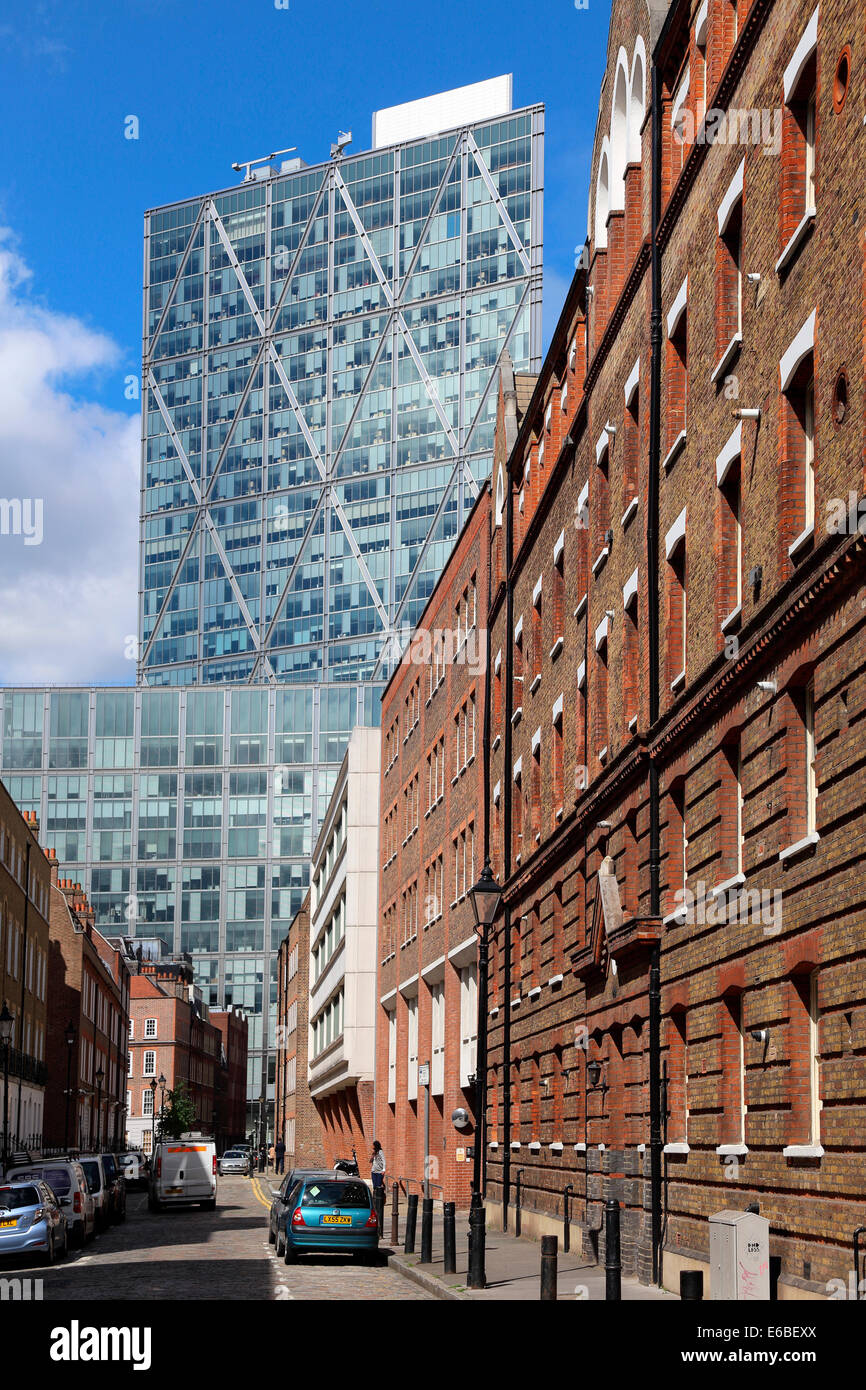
[500,460,514,1230]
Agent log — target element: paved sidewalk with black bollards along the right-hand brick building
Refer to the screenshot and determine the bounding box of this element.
[379,1198,678,1302]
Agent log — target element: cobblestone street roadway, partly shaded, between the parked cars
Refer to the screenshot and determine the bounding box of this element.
[3,1177,431,1302]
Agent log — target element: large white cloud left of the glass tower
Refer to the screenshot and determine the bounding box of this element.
[0,228,140,685]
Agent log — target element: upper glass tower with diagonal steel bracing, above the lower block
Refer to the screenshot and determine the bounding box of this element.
[139,79,544,685]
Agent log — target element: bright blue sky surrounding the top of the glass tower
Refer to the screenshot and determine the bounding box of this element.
[0,0,610,681]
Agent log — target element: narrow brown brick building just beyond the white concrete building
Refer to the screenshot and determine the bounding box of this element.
[274,892,324,1172]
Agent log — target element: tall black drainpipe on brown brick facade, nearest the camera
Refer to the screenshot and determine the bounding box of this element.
[646,61,662,1286]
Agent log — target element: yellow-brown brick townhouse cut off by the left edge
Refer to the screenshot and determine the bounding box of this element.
[0,783,50,1148]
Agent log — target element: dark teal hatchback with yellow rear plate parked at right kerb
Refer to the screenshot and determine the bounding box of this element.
[285,1177,379,1265]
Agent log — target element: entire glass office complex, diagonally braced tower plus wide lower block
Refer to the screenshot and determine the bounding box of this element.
[0,79,544,1117]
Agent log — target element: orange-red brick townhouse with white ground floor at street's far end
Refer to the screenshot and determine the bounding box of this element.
[126,938,221,1154]
